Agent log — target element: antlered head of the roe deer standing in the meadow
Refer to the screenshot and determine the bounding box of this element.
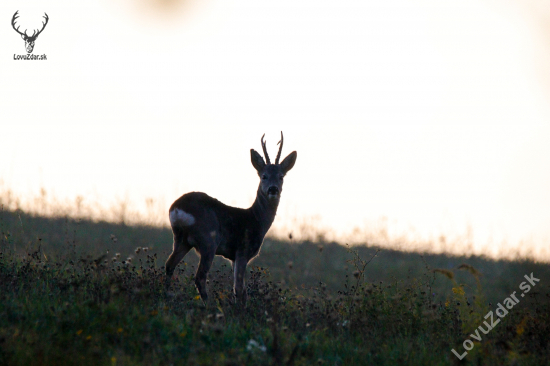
[250,131,297,203]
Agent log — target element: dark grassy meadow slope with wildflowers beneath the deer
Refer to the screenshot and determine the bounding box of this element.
[0,207,550,365]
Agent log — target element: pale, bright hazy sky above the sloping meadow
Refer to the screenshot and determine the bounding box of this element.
[0,0,550,260]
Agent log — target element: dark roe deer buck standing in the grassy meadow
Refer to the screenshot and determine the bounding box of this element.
[166,132,297,305]
